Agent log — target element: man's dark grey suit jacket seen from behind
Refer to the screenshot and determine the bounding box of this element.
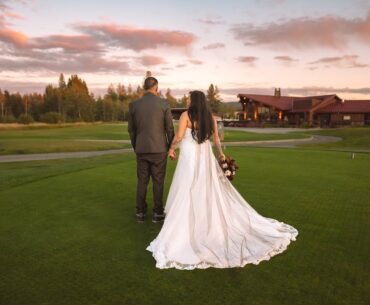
[128,92,174,153]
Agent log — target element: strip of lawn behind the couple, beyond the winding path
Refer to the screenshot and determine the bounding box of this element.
[0,123,309,155]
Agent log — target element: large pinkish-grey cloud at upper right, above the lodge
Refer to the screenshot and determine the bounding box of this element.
[231,12,370,49]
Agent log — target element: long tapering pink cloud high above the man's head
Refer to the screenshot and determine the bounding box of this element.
[75,24,195,51]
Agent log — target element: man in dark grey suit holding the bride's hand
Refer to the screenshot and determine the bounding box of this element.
[128,76,174,223]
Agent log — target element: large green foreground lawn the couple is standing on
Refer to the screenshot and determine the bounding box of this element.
[0,148,370,305]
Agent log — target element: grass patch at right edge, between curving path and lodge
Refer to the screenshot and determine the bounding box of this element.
[302,127,370,150]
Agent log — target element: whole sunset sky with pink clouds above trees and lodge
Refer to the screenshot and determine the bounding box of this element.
[0,0,370,101]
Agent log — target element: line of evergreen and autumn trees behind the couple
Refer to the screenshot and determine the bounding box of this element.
[0,74,234,124]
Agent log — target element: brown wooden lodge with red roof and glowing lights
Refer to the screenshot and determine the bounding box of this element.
[237,89,370,127]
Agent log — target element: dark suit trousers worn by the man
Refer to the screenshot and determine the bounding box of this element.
[136,153,167,214]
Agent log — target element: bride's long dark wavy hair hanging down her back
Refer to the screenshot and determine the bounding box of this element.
[188,91,213,144]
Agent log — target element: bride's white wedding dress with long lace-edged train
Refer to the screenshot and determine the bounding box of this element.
[147,128,298,270]
